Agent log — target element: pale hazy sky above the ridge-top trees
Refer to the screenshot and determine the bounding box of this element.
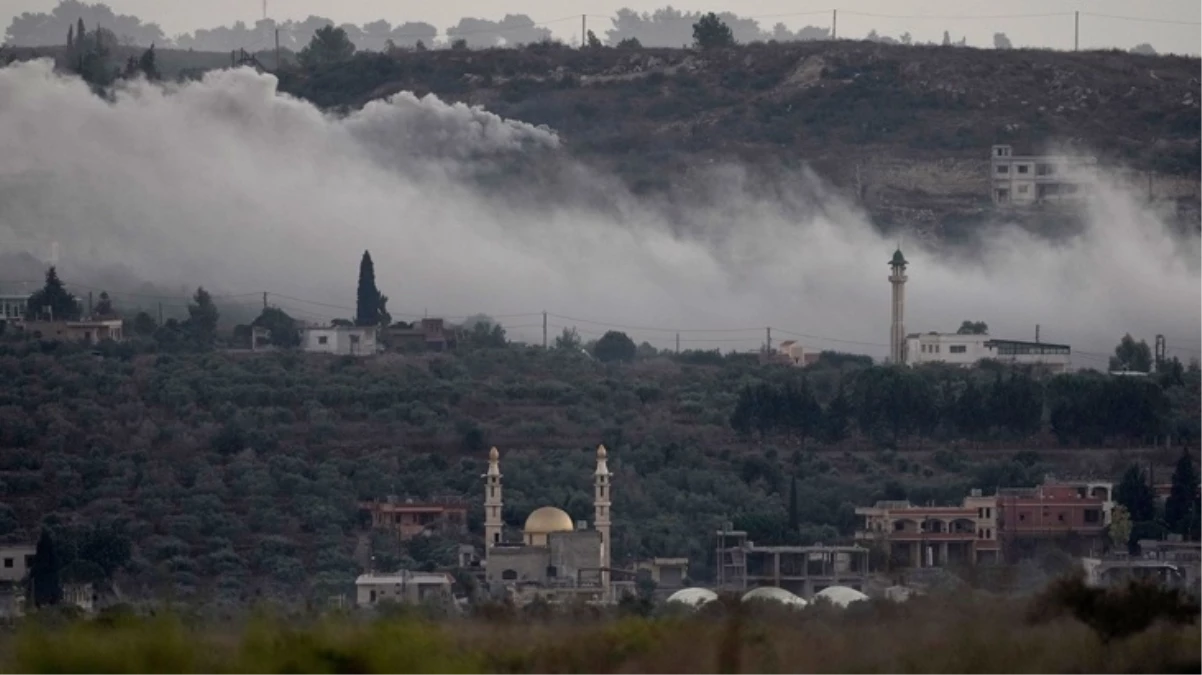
[7,0,1202,53]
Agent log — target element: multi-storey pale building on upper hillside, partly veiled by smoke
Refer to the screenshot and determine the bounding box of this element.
[989,145,1097,207]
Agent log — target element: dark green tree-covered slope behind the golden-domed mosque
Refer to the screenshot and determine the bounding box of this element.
[0,328,1202,603]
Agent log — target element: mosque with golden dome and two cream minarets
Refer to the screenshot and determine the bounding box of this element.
[483,446,623,603]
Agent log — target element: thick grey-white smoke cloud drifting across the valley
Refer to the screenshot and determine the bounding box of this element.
[0,57,1202,366]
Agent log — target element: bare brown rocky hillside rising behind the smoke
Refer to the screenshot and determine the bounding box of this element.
[268,41,1202,228]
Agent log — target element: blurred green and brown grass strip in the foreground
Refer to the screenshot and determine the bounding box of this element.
[7,586,1202,675]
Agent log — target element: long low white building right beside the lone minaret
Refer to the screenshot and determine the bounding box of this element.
[905,333,1072,372]
